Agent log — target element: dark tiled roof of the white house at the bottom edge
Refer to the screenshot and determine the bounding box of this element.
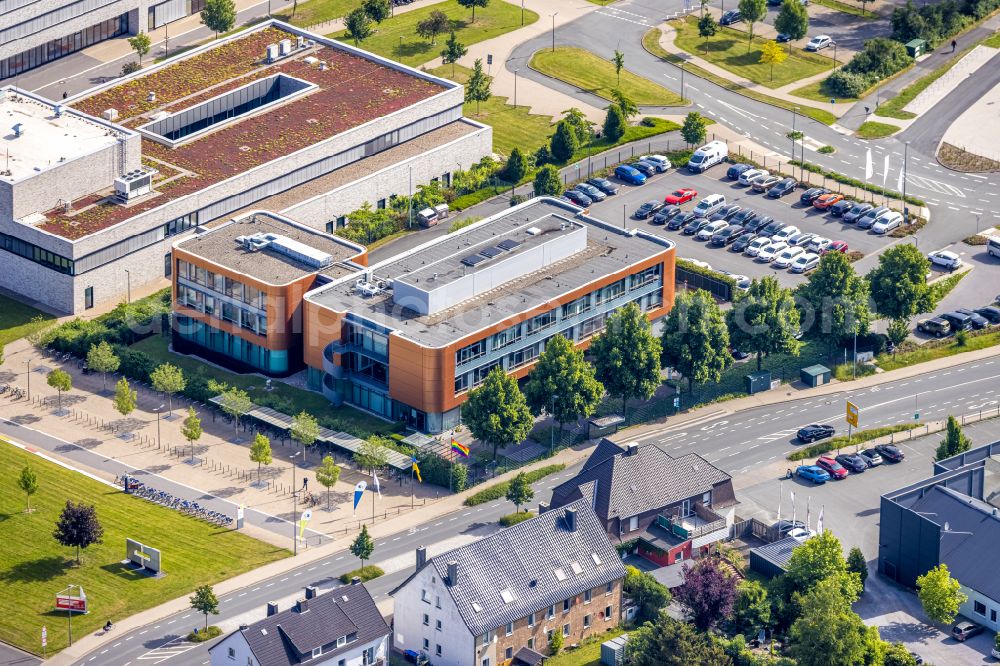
[209,585,390,666]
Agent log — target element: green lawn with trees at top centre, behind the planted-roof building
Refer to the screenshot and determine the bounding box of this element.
[332,0,538,67]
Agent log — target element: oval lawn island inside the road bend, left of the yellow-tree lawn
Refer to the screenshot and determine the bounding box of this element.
[530,46,684,106]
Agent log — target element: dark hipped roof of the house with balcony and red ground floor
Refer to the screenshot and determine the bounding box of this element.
[552,440,731,520]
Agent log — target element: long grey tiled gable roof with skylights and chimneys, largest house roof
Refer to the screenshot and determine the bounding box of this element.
[429,501,625,635]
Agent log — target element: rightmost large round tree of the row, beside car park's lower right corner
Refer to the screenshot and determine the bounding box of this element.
[868,243,935,319]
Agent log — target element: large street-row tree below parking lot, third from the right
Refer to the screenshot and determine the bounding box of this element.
[726,276,802,370]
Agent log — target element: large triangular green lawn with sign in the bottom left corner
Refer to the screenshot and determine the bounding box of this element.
[0,442,289,656]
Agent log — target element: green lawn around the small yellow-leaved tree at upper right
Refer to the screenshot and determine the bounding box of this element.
[671,16,833,88]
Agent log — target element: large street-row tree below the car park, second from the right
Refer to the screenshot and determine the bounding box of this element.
[795,252,872,351]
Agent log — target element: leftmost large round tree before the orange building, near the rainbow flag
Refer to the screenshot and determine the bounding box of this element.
[462,367,534,460]
